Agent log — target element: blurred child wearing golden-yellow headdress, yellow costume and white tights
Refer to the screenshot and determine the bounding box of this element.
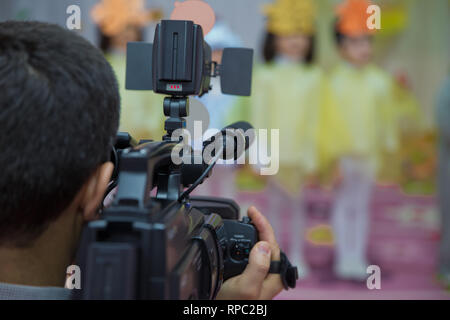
[230,0,323,276]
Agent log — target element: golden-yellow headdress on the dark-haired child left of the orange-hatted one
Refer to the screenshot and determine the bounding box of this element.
[263,0,316,36]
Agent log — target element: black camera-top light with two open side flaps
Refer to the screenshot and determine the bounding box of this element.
[125,20,253,97]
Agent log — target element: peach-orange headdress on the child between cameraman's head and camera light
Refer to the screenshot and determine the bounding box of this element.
[91,0,161,36]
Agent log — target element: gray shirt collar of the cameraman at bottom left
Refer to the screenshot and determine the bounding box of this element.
[0,283,72,300]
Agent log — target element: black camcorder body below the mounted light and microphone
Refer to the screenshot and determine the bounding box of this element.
[78,135,258,299]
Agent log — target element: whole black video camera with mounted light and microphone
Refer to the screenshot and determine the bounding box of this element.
[77,20,297,299]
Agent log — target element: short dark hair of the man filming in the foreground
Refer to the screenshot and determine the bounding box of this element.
[0,21,120,246]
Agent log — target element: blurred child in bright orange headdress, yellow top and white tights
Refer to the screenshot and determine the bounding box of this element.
[327,0,398,280]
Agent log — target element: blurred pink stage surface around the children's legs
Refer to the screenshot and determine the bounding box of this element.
[195,173,450,299]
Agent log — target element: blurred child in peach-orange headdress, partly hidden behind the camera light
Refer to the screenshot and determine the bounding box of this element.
[92,0,165,140]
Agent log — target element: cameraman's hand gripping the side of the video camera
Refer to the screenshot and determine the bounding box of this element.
[217,207,283,300]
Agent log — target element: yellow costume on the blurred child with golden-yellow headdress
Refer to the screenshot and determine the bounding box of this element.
[233,63,325,193]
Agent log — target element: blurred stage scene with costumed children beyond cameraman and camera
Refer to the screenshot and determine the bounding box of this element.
[0,0,450,299]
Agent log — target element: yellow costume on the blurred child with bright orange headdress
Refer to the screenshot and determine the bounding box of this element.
[321,62,401,169]
